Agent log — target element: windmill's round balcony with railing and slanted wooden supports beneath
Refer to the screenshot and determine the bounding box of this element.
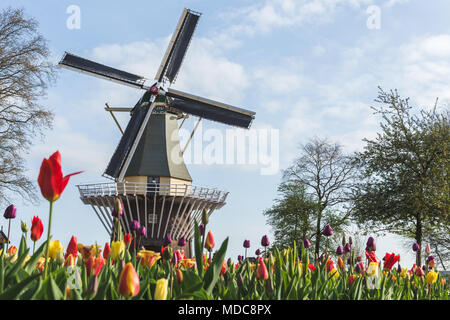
[77,181,229,254]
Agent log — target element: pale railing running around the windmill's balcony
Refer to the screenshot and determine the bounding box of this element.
[77,182,229,203]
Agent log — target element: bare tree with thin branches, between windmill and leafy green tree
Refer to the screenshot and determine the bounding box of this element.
[283,137,353,255]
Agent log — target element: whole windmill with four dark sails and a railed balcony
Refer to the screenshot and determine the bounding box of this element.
[59,9,255,256]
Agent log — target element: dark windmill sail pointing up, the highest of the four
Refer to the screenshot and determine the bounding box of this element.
[156,9,200,83]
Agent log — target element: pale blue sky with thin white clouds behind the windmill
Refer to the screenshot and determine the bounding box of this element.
[1,0,450,266]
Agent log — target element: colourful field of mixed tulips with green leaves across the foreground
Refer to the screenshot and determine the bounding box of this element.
[0,153,450,300]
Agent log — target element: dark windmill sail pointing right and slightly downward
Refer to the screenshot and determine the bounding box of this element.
[166,89,255,129]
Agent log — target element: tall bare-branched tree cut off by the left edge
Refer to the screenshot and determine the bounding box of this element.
[0,8,56,203]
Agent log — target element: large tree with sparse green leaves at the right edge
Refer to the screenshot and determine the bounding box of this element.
[353,88,450,265]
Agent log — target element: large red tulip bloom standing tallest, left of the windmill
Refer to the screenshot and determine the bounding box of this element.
[38,151,83,202]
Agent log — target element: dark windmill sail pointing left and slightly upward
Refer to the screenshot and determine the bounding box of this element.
[59,52,145,88]
